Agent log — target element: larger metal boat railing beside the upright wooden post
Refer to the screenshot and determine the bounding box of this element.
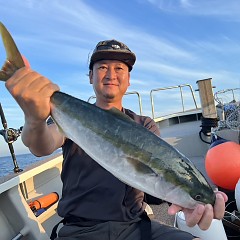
[150,84,198,119]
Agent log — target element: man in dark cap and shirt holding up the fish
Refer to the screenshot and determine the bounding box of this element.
[6,40,227,240]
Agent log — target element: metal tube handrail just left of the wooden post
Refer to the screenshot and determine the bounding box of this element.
[150,84,198,119]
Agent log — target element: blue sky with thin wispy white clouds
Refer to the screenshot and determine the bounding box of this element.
[0,0,240,156]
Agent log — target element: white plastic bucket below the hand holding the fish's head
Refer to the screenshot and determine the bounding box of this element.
[175,212,227,240]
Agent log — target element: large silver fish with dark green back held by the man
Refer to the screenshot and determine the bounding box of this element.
[0,23,215,208]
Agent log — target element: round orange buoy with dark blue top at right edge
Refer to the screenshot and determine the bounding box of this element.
[205,139,240,190]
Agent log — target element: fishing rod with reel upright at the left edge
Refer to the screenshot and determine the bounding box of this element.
[0,103,23,173]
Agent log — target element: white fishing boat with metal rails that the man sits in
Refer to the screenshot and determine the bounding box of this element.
[0,78,240,240]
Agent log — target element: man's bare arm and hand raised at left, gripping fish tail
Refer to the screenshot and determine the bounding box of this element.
[6,67,62,156]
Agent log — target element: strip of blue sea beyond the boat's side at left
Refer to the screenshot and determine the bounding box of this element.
[0,149,61,177]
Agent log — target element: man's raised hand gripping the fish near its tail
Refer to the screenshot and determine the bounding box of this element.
[6,67,59,124]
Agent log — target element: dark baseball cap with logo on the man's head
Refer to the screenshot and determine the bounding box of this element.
[89,39,136,72]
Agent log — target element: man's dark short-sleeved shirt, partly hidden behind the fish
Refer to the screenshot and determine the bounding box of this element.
[58,109,160,221]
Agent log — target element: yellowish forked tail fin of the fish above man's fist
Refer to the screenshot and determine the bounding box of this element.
[0,22,25,81]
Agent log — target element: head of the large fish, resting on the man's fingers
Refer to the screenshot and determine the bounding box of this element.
[156,152,215,209]
